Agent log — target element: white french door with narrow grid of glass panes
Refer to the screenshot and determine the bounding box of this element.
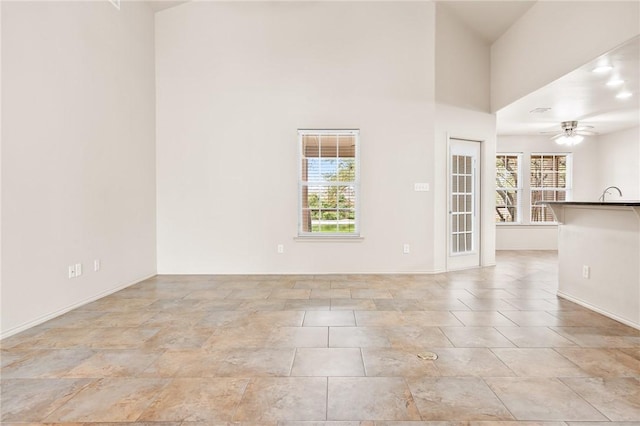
[447,138,480,270]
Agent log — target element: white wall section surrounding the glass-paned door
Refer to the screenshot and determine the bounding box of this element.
[432,104,496,271]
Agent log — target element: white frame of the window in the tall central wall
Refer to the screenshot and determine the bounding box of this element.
[298,129,360,239]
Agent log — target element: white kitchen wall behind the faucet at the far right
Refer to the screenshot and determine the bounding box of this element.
[597,127,640,200]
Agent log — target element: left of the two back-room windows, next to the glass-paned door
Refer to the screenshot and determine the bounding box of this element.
[495,154,522,223]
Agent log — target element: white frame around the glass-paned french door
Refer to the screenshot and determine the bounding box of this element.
[445,133,486,271]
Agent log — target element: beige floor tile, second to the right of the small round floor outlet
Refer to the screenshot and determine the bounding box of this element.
[492,348,587,377]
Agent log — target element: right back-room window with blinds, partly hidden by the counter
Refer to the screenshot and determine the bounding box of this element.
[529,154,571,223]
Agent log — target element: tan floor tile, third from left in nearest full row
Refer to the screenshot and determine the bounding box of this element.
[139,378,249,422]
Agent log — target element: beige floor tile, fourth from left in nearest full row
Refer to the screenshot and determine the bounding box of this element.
[234,377,327,422]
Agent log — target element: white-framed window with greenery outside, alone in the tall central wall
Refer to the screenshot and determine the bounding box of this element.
[298,130,360,236]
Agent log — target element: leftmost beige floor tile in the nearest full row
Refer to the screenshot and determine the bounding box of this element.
[0,378,91,424]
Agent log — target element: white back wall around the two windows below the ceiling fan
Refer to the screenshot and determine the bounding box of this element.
[496,136,601,250]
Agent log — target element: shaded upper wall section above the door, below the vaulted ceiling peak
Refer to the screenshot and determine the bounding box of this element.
[435,3,491,112]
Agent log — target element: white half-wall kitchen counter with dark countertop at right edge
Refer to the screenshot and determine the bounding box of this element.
[540,201,640,329]
